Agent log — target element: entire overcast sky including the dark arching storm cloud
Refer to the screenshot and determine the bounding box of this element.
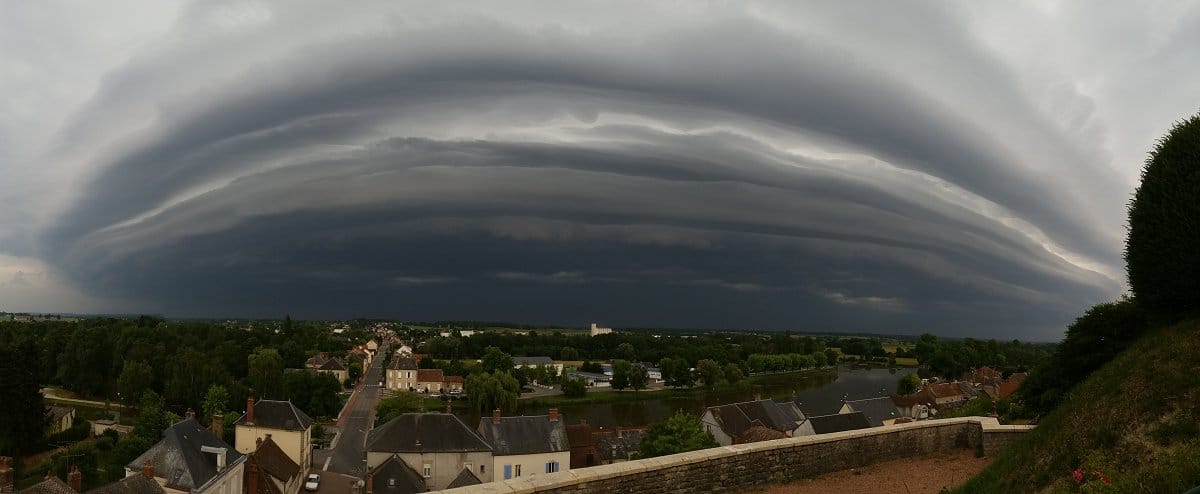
[0,0,1200,339]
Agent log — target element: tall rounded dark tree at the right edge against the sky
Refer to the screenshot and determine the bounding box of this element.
[1124,114,1200,320]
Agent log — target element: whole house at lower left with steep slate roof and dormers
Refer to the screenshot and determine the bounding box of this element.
[125,416,246,494]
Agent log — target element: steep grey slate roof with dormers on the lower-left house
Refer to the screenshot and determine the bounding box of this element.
[125,418,242,490]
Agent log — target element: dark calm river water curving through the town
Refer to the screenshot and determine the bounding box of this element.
[467,365,914,427]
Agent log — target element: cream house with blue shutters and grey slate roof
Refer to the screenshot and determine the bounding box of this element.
[476,408,571,480]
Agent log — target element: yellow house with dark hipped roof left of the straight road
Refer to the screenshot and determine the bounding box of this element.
[234,397,313,471]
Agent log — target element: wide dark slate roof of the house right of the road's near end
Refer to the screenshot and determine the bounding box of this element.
[367,414,492,453]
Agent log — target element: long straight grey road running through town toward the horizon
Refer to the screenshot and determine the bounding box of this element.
[326,345,388,478]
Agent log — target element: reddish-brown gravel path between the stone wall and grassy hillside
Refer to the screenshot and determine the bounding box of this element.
[754,450,991,494]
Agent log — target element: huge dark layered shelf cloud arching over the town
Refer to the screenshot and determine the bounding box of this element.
[9,4,1166,338]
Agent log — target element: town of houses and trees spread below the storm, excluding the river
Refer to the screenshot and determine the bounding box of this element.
[0,314,1050,494]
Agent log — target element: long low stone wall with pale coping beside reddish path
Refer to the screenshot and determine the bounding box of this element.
[432,417,1031,494]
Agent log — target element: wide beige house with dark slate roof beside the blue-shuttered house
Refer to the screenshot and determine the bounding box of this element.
[366,414,493,490]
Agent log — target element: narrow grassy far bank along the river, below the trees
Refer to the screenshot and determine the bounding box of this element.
[521,367,838,408]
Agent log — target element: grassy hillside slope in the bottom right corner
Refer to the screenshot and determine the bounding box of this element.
[956,319,1200,493]
